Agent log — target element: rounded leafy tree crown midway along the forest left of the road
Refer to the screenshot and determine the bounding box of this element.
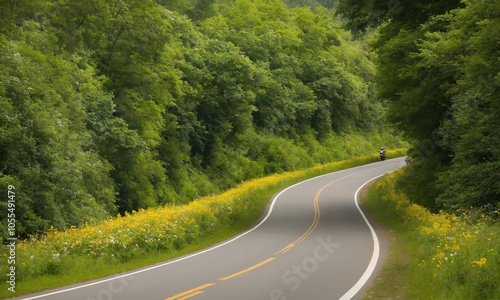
[180,40,257,166]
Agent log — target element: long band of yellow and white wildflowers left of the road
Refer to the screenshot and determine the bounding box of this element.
[0,156,396,278]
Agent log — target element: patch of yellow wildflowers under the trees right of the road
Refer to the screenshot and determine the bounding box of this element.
[377,170,498,276]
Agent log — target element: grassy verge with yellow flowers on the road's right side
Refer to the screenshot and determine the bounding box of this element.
[362,169,500,300]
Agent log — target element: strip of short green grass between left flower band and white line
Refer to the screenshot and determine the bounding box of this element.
[0,149,406,299]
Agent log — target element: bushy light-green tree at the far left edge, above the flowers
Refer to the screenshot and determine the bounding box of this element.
[0,40,115,235]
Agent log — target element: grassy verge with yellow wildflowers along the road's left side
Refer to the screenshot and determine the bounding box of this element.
[0,149,406,299]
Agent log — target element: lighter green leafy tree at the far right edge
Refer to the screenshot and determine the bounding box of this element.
[421,1,500,207]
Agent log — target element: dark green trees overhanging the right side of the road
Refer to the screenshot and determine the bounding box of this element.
[338,0,500,211]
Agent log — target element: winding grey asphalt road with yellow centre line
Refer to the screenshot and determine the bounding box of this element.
[13,158,405,300]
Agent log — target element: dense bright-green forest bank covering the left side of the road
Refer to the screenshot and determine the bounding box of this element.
[0,0,404,237]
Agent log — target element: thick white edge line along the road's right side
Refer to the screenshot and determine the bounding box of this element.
[339,171,393,300]
